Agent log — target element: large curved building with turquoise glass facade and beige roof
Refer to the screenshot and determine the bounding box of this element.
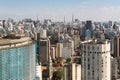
[0,37,36,80]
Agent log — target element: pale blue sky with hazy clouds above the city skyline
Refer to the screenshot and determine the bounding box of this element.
[0,0,120,21]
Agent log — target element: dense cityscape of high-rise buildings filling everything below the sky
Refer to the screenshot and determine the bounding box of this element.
[0,17,120,80]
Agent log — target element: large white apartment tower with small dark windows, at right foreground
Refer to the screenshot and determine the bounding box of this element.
[81,40,111,80]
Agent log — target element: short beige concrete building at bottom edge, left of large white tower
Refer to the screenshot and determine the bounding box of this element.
[63,63,81,80]
